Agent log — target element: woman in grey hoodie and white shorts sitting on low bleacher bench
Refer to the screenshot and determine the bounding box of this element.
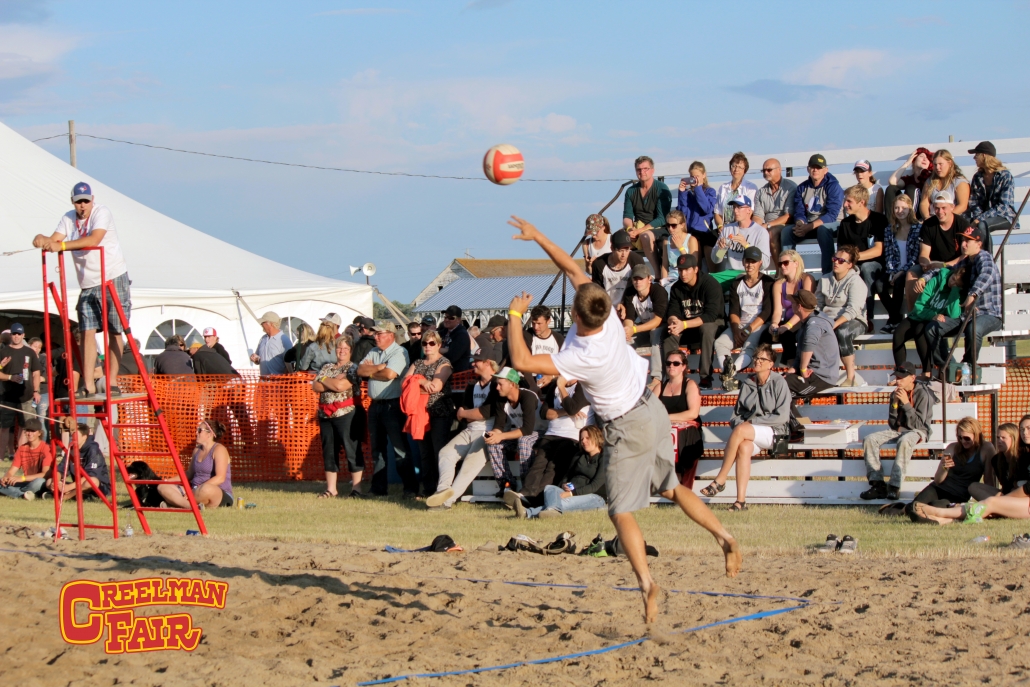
[701,344,790,511]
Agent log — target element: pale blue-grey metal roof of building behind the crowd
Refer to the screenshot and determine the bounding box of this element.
[413,276,576,313]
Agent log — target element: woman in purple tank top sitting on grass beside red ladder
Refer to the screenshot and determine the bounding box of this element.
[158,420,234,508]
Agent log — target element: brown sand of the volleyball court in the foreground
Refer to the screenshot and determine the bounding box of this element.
[0,527,1030,686]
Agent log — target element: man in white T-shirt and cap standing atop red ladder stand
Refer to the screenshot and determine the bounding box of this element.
[32,181,132,396]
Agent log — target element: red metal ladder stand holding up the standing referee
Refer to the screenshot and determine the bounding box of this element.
[42,246,207,540]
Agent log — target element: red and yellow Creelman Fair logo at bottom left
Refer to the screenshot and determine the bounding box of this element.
[61,577,229,654]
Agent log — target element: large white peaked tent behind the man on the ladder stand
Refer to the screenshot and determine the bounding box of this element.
[0,124,372,369]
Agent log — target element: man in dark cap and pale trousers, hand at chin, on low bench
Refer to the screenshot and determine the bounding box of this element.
[859,363,937,501]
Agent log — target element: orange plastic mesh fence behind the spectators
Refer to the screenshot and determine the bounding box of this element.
[118,358,1030,482]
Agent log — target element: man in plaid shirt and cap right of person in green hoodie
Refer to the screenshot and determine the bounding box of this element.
[925,227,1002,376]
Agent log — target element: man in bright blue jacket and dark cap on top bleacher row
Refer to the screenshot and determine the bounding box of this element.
[780,152,844,274]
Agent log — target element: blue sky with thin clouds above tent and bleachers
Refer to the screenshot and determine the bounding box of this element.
[0,0,1030,301]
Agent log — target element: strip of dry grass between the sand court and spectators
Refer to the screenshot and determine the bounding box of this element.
[0,475,1030,557]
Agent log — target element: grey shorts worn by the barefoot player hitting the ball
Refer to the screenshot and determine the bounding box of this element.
[602,389,680,515]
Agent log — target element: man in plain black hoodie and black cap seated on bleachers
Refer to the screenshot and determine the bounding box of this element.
[661,253,725,389]
